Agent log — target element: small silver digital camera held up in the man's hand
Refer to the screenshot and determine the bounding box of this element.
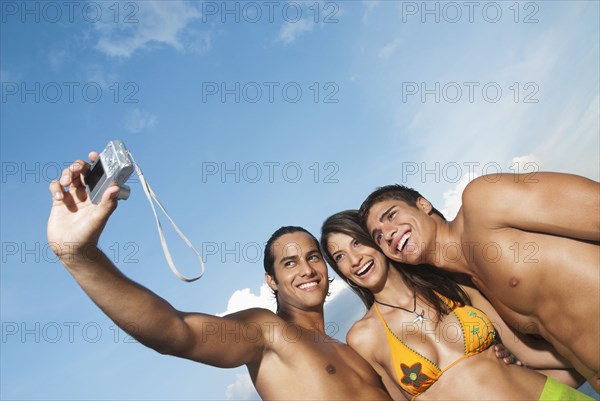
[85,139,135,205]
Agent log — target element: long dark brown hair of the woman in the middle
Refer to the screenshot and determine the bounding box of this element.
[321,210,471,318]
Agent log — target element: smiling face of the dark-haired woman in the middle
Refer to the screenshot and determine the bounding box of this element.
[327,233,388,291]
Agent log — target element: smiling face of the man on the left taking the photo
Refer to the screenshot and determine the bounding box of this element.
[266,231,329,310]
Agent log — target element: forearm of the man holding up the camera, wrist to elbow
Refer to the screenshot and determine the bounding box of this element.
[63,250,186,353]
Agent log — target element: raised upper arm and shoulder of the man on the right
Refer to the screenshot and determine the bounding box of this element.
[463,172,600,242]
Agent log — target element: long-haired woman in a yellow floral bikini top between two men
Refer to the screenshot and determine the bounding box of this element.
[321,211,592,401]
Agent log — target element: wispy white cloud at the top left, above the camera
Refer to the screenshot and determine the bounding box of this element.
[95,1,205,57]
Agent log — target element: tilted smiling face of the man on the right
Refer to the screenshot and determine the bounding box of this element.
[366,198,435,265]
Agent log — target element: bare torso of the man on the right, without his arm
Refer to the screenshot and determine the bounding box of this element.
[455,211,600,378]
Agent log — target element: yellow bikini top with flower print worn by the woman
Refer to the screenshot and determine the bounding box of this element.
[373,292,496,399]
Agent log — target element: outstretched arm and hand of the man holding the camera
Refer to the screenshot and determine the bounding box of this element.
[48,153,268,367]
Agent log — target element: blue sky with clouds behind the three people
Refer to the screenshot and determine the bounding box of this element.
[0,0,600,400]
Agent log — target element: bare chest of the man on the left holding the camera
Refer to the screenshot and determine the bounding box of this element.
[248,316,390,400]
